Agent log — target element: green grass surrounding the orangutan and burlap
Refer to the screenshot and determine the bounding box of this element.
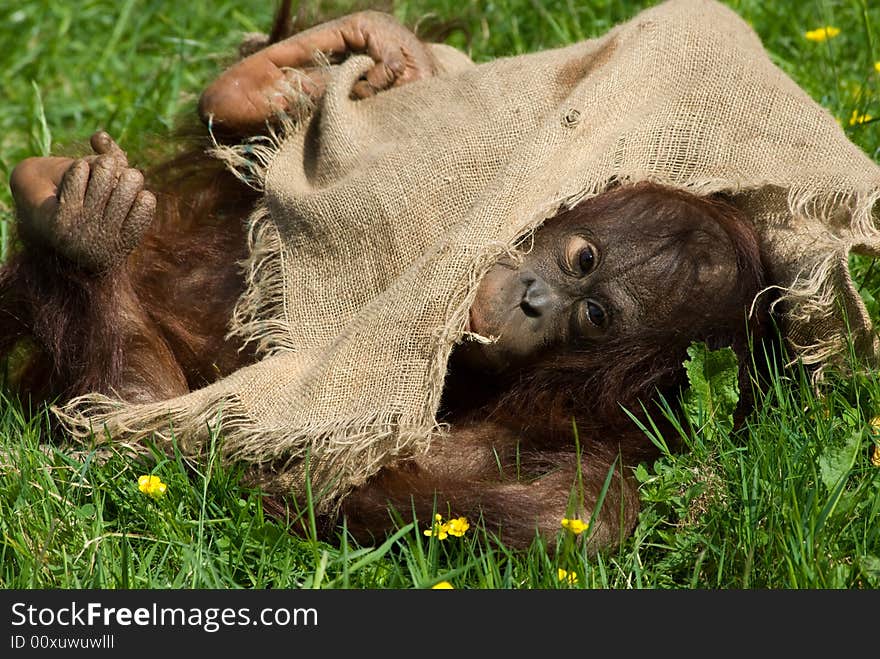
[0,0,880,588]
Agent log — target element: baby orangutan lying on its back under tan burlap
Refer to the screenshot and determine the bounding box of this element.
[0,6,764,550]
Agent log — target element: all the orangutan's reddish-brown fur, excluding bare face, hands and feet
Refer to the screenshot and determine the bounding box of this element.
[0,3,762,548]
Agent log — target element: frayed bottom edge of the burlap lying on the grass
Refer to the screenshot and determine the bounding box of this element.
[52,394,443,514]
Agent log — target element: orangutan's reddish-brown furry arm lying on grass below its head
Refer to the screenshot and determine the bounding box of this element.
[342,418,647,549]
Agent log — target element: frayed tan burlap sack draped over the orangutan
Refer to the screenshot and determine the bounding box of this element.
[61,0,880,510]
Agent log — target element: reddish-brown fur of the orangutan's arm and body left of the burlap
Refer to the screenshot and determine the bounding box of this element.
[0,150,256,402]
